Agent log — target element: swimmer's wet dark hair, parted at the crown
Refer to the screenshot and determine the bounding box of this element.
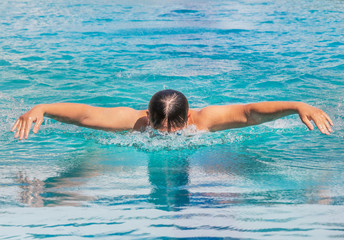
[148,89,189,131]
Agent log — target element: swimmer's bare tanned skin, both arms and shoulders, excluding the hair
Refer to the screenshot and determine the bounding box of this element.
[11,102,333,140]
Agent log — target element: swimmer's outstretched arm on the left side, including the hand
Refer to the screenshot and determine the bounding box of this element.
[11,103,144,140]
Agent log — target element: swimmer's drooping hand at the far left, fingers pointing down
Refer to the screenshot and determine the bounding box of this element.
[11,105,44,140]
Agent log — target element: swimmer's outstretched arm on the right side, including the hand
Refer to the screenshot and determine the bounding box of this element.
[195,102,333,135]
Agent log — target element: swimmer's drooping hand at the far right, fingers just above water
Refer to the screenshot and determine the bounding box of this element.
[298,103,333,135]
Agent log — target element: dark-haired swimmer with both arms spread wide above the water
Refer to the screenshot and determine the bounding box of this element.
[11,89,333,140]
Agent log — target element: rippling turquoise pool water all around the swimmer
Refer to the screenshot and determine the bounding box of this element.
[0,0,344,240]
